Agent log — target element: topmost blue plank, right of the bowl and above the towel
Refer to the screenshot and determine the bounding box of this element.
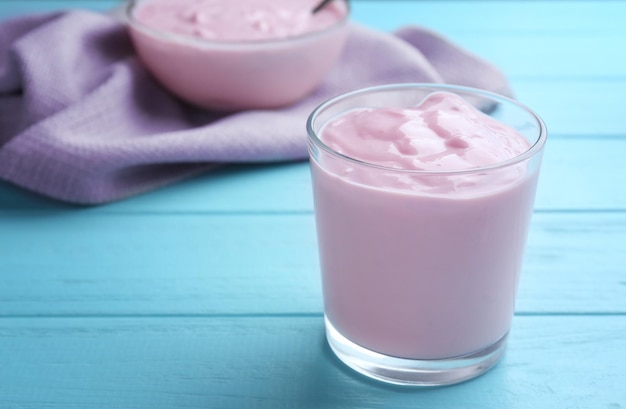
[352,0,626,36]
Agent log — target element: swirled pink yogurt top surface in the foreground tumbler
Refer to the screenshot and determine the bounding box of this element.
[321,92,530,171]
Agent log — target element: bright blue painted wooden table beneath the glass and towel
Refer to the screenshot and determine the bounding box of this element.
[0,0,626,409]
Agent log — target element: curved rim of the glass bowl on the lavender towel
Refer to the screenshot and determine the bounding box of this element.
[124,0,351,50]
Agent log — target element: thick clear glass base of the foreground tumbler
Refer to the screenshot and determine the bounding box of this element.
[325,319,508,386]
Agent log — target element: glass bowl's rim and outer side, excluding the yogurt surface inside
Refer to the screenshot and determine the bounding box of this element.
[126,0,349,111]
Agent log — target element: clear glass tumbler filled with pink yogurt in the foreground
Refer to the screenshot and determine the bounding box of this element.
[307,84,547,386]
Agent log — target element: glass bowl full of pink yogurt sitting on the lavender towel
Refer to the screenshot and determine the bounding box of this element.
[126,0,349,111]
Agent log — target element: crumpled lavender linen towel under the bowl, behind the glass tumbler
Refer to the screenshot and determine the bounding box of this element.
[0,11,510,204]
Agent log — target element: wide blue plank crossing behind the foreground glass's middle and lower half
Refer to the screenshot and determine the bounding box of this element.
[0,211,626,316]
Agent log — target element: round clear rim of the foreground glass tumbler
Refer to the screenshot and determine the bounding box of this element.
[306,83,548,176]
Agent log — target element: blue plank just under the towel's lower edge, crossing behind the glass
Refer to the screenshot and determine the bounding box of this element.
[0,135,626,210]
